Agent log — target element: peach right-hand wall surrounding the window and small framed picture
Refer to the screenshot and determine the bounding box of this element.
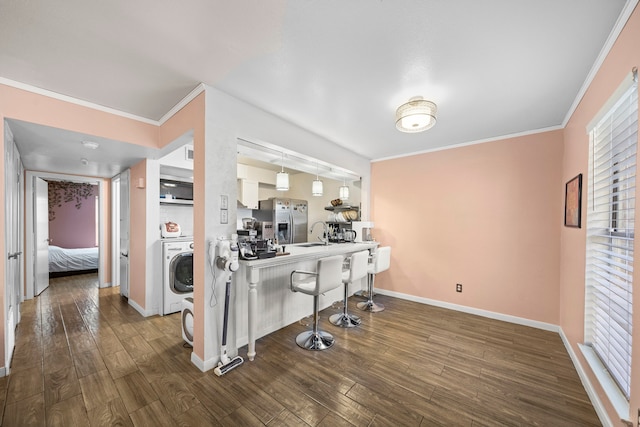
[560,7,640,425]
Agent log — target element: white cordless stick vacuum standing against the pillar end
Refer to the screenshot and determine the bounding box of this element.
[213,234,244,377]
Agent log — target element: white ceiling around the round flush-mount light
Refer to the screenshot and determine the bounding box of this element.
[0,0,637,177]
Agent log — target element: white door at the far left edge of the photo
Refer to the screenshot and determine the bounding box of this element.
[4,128,22,374]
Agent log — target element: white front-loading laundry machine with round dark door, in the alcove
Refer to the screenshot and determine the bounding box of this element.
[161,239,193,315]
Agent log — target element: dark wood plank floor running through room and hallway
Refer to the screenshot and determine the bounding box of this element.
[0,275,601,427]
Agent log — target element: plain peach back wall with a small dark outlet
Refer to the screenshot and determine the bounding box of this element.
[371,131,563,324]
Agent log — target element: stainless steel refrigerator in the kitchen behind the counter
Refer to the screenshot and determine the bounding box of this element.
[254,198,308,245]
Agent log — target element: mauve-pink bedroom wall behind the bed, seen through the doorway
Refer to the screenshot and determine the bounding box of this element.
[49,182,98,248]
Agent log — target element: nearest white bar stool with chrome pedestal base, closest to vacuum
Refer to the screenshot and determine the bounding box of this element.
[290,255,344,350]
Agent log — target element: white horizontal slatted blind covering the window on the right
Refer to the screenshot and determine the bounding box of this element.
[585,68,638,400]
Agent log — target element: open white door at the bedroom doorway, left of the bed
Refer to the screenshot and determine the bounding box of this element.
[33,177,49,295]
